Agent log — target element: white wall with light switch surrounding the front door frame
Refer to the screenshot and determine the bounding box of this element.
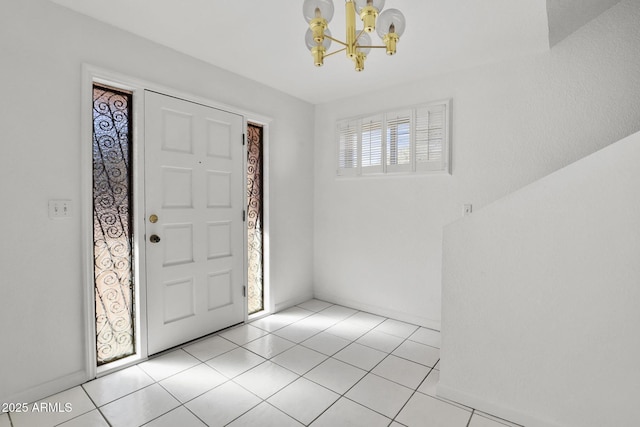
[0,0,314,402]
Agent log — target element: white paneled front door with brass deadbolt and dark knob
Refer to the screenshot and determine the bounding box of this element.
[144,91,245,355]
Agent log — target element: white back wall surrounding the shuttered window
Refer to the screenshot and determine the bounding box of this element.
[314,0,640,329]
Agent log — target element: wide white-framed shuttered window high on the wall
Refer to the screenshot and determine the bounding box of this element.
[338,100,451,176]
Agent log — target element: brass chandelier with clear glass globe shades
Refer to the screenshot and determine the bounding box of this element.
[302,0,406,71]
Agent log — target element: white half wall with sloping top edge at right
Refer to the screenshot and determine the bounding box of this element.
[438,133,640,427]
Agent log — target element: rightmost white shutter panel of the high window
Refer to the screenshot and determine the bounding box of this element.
[415,103,449,171]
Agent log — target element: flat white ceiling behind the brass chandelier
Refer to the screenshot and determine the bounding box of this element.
[52,0,549,103]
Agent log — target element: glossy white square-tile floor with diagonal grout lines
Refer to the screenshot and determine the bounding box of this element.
[0,299,515,427]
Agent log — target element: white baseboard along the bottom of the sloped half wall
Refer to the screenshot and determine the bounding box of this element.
[436,383,562,427]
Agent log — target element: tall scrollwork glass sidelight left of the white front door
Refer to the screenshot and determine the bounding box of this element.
[93,85,135,365]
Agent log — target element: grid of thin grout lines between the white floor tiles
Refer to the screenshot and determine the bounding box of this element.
[7,304,520,427]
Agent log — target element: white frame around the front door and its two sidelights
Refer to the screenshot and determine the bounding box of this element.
[80,64,274,380]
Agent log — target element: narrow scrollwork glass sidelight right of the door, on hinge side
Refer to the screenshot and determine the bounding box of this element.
[247,123,264,314]
